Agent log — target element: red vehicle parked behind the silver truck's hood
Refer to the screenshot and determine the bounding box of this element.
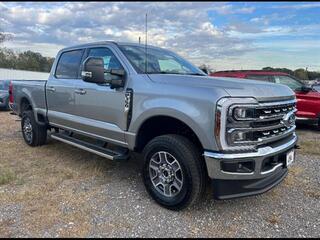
[210,70,320,130]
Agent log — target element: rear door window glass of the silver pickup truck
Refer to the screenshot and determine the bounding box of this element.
[55,50,83,78]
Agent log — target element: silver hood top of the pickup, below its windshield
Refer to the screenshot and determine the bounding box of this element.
[148,74,295,101]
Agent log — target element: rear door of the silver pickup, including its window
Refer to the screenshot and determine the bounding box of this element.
[46,49,84,128]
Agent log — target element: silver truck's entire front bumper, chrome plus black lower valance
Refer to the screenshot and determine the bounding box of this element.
[204,134,298,199]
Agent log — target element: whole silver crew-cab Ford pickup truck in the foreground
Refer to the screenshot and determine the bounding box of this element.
[10,41,297,210]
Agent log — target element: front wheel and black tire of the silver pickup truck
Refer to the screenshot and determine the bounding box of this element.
[142,135,206,210]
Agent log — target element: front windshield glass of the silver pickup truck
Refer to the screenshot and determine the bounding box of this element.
[119,45,206,76]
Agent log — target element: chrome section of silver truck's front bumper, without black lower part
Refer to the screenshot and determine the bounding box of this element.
[203,133,298,180]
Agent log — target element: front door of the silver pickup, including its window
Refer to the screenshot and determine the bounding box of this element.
[75,47,126,145]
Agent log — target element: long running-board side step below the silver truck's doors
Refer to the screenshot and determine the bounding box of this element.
[51,133,129,161]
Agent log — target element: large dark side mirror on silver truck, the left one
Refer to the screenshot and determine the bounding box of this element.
[81,57,106,83]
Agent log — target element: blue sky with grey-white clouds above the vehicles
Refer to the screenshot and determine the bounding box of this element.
[0,2,320,71]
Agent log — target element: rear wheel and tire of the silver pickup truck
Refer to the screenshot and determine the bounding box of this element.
[21,111,47,147]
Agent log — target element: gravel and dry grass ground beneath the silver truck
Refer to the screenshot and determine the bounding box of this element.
[0,112,320,237]
